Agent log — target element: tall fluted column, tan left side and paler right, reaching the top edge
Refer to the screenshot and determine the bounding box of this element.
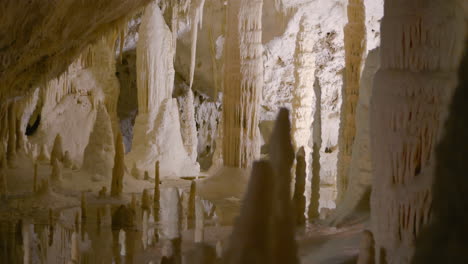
[222,0,263,168]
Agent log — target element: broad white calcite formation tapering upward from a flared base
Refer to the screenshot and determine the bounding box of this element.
[126,3,199,176]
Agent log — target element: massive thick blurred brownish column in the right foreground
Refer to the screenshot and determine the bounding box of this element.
[370,0,466,264]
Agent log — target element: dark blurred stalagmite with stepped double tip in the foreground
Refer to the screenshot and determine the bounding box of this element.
[227,108,299,264]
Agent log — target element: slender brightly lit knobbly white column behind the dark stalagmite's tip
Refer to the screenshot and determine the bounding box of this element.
[291,16,315,173]
